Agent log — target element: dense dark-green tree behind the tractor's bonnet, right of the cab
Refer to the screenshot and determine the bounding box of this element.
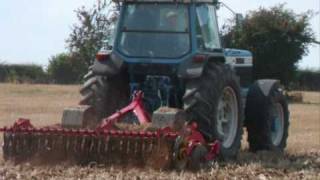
[224,4,314,85]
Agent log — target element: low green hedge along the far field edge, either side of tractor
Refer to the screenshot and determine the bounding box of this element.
[0,63,320,91]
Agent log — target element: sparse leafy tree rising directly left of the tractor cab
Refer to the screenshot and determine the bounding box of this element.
[66,0,118,67]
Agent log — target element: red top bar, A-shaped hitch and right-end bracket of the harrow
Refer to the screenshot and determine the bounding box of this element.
[0,91,220,164]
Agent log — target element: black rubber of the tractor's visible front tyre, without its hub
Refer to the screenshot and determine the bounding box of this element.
[245,85,290,152]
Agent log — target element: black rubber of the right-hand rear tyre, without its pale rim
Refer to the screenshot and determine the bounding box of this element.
[183,62,243,160]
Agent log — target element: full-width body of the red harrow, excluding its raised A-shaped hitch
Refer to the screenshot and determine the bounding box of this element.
[0,116,219,169]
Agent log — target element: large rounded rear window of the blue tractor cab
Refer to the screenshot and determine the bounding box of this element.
[118,3,190,58]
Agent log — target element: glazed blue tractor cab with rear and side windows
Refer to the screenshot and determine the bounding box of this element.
[114,0,222,64]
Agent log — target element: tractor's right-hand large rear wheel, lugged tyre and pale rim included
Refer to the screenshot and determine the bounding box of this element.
[183,62,243,160]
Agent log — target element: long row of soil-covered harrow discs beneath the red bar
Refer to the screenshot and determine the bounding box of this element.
[3,129,174,169]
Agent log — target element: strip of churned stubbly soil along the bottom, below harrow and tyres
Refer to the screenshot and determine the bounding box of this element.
[0,152,320,180]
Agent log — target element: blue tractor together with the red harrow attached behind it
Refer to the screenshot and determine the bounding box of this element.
[0,0,289,167]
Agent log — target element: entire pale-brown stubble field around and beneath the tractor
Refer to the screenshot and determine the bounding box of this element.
[0,84,320,180]
